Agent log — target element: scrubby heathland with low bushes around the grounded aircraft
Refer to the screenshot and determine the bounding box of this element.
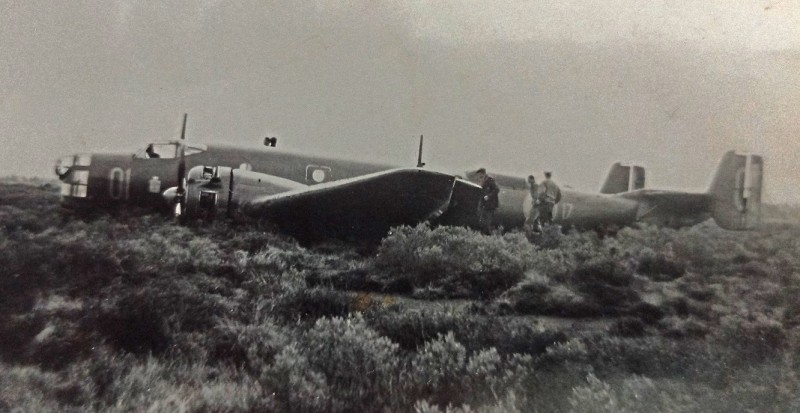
[0,183,800,412]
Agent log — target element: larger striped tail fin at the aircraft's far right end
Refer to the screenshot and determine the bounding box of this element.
[709,151,764,230]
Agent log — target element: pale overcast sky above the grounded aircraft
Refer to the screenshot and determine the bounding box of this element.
[0,0,800,202]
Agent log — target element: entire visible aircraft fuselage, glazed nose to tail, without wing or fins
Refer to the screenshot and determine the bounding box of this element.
[56,142,707,229]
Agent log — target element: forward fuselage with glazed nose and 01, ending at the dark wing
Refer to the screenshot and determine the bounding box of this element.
[56,144,391,207]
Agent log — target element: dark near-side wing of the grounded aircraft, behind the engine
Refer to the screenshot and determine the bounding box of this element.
[238,169,480,240]
